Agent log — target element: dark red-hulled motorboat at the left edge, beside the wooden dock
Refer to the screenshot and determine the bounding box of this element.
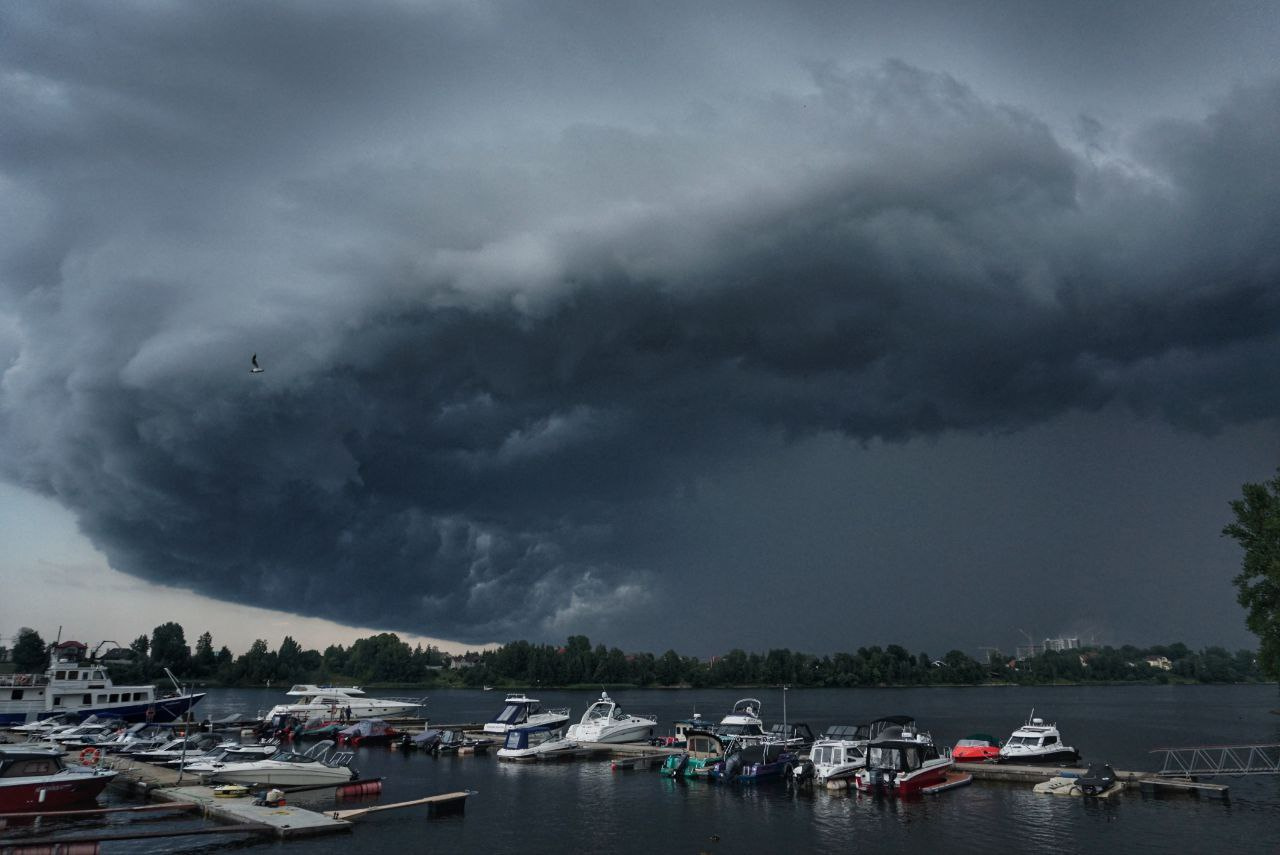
[0,745,118,813]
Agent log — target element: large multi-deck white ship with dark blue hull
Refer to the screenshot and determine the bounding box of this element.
[0,653,205,727]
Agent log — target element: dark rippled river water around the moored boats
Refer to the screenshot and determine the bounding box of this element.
[35,686,1280,855]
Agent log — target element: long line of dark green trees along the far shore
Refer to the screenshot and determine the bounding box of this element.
[0,622,1263,687]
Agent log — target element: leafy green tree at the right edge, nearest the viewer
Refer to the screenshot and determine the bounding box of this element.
[1222,475,1280,680]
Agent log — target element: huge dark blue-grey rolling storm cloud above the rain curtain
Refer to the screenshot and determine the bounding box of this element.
[0,4,1280,641]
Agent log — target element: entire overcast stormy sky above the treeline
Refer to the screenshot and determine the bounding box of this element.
[0,0,1280,655]
